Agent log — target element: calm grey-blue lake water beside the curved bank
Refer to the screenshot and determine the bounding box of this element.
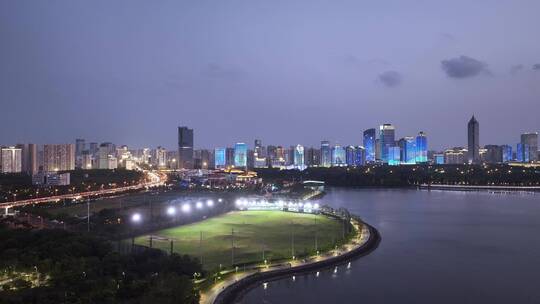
[240,189,540,303]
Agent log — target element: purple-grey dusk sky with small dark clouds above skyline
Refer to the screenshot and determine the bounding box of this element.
[0,0,540,149]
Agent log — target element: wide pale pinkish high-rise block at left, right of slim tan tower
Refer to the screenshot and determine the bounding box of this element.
[43,144,75,172]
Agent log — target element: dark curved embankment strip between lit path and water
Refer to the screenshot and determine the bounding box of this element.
[209,219,381,304]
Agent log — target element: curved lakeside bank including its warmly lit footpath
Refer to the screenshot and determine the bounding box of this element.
[200,218,380,304]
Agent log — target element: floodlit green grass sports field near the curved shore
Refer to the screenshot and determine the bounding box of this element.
[135,211,342,270]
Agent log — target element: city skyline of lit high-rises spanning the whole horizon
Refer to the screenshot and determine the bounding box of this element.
[0,116,539,175]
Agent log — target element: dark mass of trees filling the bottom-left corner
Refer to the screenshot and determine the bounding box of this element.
[0,228,202,304]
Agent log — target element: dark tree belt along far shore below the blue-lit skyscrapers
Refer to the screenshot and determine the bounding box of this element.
[257,164,540,187]
